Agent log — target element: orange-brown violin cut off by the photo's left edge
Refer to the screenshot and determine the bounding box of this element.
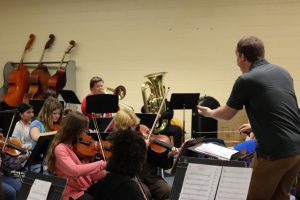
[0,133,27,157]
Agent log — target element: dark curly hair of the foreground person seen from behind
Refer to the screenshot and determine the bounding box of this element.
[107,129,147,177]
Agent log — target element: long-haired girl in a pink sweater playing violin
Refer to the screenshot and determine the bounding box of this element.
[46,111,106,200]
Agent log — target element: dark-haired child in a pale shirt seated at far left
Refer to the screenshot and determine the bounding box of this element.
[12,103,34,150]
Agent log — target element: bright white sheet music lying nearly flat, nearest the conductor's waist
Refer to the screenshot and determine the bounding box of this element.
[195,143,238,160]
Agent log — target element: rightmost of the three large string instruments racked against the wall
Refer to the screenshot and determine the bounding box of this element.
[47,40,76,97]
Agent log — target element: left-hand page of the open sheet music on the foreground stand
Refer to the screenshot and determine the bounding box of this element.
[179,163,222,200]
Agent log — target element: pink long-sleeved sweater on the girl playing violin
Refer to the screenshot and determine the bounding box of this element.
[54,143,106,200]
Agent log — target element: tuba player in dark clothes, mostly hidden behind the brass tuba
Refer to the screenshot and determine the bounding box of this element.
[141,100,183,148]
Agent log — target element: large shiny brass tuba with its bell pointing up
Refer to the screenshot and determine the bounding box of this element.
[142,72,168,134]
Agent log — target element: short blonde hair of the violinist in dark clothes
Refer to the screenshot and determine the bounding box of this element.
[114,109,140,130]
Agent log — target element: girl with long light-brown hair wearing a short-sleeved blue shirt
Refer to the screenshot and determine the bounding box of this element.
[29,97,63,148]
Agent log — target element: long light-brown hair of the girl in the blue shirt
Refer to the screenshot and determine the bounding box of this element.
[37,97,63,132]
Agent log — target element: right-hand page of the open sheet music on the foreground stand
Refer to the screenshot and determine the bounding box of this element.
[216,167,252,200]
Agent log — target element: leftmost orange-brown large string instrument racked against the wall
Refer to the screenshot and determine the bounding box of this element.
[2,34,35,107]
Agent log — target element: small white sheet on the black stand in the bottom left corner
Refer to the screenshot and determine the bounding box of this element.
[27,179,51,200]
